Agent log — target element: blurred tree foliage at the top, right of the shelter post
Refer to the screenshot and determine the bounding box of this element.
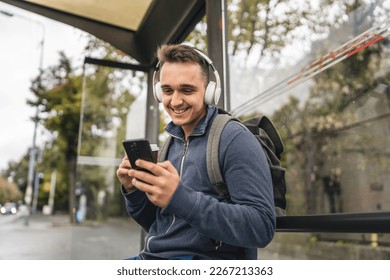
[228,0,356,63]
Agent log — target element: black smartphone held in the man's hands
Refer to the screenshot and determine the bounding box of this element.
[122,139,156,173]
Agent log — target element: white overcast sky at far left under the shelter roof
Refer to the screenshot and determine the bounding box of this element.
[0,2,86,170]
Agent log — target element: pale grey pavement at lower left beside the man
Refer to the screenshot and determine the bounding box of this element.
[0,214,141,260]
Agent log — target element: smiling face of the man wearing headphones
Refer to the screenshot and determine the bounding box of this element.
[160,62,207,137]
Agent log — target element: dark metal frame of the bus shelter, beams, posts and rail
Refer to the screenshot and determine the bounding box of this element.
[0,0,390,233]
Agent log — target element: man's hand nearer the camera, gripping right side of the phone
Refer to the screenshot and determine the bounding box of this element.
[128,159,180,208]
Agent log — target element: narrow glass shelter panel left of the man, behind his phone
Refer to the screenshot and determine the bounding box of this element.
[76,65,146,219]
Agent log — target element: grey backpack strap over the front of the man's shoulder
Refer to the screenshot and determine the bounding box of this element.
[206,114,237,198]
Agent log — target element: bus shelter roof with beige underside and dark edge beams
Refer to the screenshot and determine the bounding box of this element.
[0,0,206,67]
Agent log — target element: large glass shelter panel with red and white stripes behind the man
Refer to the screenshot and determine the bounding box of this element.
[228,0,390,259]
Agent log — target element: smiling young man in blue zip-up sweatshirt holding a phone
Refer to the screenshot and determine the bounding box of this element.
[117,45,275,259]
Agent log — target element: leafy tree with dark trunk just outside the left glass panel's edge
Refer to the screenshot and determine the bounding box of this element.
[29,52,82,222]
